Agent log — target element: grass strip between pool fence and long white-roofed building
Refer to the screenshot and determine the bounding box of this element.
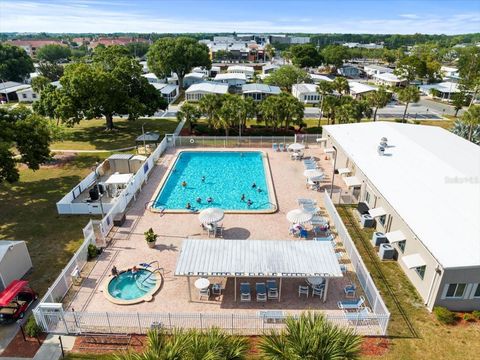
[338,206,480,360]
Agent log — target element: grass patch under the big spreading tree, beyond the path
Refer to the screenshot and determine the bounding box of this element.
[51,118,178,150]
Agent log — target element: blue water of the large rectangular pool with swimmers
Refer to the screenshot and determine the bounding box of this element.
[153,151,273,211]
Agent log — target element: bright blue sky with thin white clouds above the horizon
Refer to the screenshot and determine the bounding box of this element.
[0,0,480,35]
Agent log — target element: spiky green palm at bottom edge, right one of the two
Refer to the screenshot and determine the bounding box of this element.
[258,313,362,360]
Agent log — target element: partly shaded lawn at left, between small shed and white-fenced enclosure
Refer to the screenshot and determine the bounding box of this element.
[0,153,105,294]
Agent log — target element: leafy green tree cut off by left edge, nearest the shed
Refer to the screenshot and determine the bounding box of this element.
[0,105,53,183]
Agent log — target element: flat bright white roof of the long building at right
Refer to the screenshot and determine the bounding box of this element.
[323,121,480,268]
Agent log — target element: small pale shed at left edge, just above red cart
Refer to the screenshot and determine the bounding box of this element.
[0,240,32,291]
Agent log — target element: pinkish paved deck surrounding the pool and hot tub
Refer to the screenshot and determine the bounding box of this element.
[66,146,366,320]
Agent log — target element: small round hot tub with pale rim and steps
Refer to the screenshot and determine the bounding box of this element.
[105,269,161,305]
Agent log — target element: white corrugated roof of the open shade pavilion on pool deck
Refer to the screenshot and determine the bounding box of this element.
[175,239,343,278]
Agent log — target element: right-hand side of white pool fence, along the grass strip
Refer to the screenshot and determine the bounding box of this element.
[323,191,390,335]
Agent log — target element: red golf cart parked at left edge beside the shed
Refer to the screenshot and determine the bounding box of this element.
[0,280,38,324]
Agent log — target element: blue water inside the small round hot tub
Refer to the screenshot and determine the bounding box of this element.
[108,270,157,300]
